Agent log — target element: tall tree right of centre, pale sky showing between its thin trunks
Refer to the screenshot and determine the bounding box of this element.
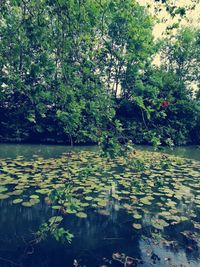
[97,0,154,98]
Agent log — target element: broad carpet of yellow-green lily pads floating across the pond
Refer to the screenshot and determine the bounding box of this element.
[0,150,200,246]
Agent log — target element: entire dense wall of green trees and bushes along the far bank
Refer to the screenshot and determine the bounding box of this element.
[0,0,200,145]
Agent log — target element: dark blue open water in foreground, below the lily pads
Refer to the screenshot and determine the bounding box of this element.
[0,201,200,267]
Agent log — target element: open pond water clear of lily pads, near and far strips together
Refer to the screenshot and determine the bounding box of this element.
[0,144,200,267]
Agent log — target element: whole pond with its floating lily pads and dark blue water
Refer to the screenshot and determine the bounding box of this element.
[0,145,200,267]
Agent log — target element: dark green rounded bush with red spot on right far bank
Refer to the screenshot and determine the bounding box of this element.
[117,60,200,148]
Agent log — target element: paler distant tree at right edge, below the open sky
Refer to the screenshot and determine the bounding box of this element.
[162,27,200,84]
